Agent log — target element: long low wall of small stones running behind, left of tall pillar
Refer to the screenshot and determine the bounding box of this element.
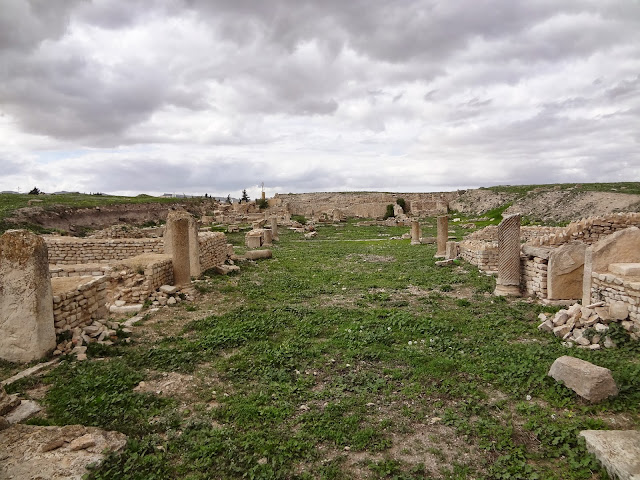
[43,236,164,265]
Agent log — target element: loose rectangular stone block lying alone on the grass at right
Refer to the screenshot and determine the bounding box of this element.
[549,355,618,402]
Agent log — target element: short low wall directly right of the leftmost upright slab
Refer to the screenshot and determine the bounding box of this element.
[51,276,108,334]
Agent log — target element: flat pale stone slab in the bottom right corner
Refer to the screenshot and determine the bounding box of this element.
[580,430,640,480]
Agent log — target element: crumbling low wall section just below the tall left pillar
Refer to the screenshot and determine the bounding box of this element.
[107,254,173,303]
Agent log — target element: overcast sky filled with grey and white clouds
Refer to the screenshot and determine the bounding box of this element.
[0,0,640,197]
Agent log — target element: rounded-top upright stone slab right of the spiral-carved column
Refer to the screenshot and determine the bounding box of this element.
[547,242,587,300]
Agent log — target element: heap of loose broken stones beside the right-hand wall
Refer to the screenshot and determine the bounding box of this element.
[538,302,637,350]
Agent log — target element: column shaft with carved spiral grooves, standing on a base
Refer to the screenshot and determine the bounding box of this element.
[493,213,520,296]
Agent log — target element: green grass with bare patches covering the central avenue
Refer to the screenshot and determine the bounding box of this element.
[5,219,640,480]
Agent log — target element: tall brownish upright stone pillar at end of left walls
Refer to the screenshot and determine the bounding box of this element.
[164,210,192,285]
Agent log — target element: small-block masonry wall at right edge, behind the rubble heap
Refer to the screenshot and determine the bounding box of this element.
[591,272,640,324]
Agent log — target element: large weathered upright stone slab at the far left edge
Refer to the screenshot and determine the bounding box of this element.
[0,230,56,363]
